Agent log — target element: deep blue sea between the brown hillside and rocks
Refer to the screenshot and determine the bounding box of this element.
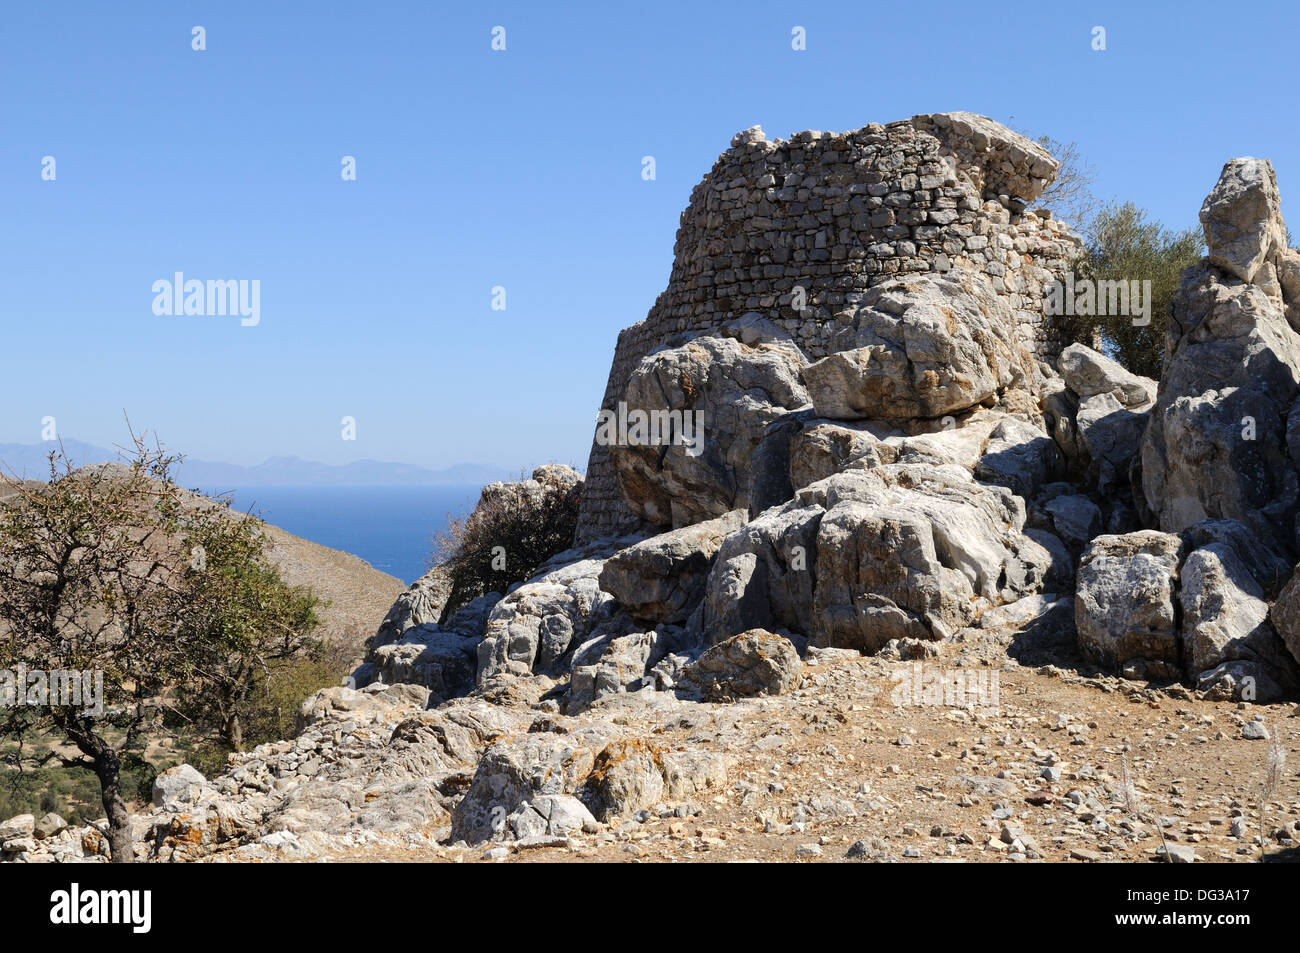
[204,486,482,582]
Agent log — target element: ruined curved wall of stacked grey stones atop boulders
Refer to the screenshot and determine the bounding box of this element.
[577,113,1079,542]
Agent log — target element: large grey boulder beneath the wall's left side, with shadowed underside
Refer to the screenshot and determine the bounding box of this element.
[611,328,810,527]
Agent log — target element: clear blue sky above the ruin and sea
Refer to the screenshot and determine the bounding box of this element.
[0,0,1300,467]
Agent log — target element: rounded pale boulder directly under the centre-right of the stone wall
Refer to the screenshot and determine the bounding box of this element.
[803,269,1032,420]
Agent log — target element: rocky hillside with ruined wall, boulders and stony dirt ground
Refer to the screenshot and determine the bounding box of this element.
[5,113,1300,862]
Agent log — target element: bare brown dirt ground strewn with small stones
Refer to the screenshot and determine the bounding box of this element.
[297,631,1300,863]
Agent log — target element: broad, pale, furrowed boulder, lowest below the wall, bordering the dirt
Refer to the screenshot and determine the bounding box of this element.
[701,464,1052,651]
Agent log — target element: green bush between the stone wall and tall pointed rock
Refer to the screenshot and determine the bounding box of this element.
[1058,202,1203,380]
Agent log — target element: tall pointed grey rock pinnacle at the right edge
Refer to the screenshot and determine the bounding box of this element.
[1141,159,1300,553]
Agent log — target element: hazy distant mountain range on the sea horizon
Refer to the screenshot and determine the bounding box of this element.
[0,439,519,489]
